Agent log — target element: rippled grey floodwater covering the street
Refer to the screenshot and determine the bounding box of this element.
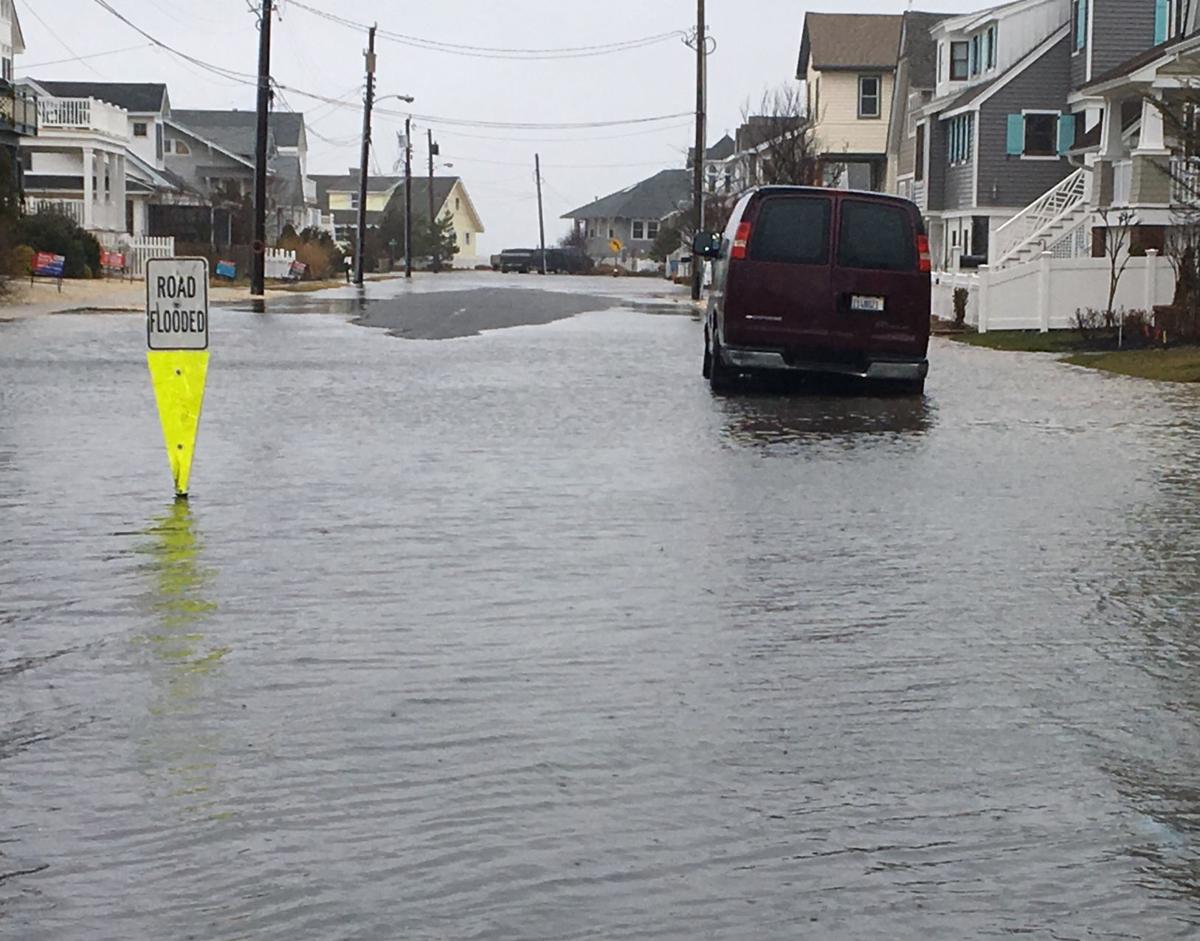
[0,272,1200,941]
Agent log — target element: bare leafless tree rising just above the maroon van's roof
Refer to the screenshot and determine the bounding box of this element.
[737,85,836,186]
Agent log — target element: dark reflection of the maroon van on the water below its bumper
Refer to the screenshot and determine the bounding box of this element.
[722,392,934,445]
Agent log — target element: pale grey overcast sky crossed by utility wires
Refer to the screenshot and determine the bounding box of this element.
[17,0,986,253]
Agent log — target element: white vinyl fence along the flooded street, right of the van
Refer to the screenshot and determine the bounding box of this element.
[934,248,1175,334]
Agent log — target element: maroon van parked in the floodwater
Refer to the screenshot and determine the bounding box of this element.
[692,186,930,395]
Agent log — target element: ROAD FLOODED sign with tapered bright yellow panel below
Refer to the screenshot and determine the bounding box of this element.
[146,258,209,497]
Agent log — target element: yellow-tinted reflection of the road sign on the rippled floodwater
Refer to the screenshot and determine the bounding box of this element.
[138,501,230,815]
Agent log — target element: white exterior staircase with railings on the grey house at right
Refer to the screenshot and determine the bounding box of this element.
[991,169,1092,268]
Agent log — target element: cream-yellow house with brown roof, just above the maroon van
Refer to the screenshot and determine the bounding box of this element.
[796,13,902,190]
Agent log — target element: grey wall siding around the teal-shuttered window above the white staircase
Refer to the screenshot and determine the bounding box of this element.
[976,38,1072,208]
